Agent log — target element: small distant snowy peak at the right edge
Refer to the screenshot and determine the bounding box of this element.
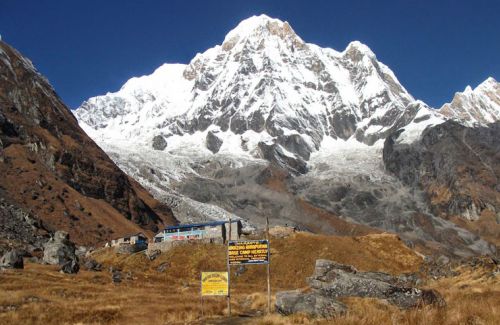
[440,77,500,125]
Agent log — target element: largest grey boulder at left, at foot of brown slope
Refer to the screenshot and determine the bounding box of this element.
[43,231,79,273]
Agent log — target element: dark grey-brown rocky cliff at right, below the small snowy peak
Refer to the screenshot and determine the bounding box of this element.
[383,121,500,243]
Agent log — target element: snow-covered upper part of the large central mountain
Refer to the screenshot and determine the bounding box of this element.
[75,15,426,170]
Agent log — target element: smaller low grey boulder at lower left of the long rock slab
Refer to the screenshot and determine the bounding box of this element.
[276,290,347,318]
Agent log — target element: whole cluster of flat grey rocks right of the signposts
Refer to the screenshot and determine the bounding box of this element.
[276,260,445,318]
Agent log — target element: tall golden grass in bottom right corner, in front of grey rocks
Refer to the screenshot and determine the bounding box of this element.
[254,260,500,325]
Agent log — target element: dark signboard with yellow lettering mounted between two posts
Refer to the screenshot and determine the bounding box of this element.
[228,240,269,265]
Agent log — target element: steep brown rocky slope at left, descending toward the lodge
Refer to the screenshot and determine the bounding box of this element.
[0,42,174,244]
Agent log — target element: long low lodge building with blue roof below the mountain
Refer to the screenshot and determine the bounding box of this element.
[153,220,242,243]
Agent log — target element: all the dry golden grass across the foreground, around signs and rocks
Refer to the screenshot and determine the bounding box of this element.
[0,233,500,324]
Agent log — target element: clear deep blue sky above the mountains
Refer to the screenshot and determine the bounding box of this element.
[0,0,500,108]
